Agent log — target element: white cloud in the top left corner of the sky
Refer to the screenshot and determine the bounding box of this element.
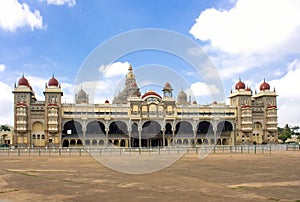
[0,0,43,32]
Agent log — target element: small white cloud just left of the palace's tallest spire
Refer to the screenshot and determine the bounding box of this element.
[98,62,130,78]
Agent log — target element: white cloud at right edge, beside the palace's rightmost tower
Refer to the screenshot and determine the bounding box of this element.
[269,59,300,126]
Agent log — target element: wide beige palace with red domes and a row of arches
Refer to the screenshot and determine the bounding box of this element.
[13,66,278,147]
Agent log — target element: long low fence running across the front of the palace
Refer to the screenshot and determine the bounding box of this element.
[0,144,300,156]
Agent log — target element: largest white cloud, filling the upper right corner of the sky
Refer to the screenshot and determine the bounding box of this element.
[190,0,300,53]
